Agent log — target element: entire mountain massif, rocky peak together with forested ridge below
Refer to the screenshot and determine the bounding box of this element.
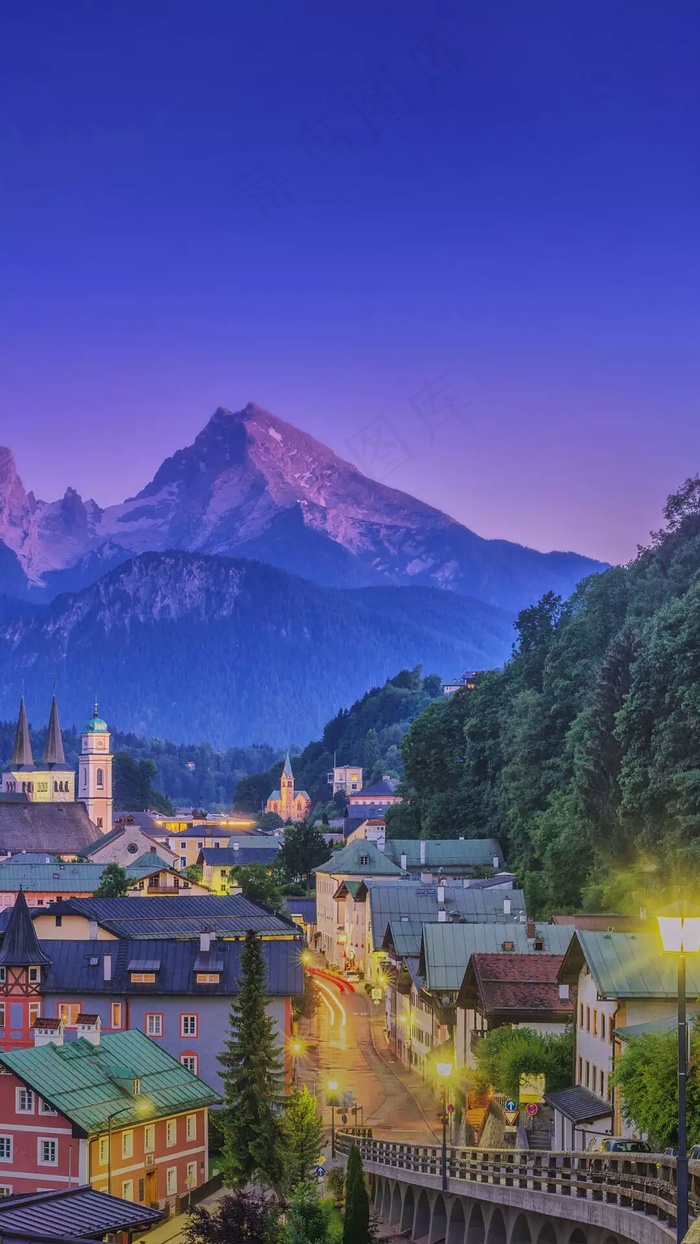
[0,404,602,745]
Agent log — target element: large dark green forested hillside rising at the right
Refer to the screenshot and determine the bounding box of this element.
[389,476,700,913]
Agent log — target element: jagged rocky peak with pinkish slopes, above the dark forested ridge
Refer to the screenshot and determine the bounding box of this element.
[0,403,602,611]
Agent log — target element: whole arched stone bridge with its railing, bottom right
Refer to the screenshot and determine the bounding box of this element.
[337,1130,700,1244]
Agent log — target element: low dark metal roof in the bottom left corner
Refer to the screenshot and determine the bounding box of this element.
[0,1184,163,1239]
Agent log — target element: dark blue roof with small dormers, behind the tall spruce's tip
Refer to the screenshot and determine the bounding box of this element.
[40,927,303,998]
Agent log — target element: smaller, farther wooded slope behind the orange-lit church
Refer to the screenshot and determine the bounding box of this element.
[235,666,443,812]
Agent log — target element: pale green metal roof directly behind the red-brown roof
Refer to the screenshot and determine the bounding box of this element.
[420,923,572,991]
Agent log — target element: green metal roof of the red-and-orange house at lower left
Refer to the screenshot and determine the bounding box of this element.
[0,1029,220,1136]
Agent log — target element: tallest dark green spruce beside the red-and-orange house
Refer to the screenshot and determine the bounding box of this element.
[219,931,282,1189]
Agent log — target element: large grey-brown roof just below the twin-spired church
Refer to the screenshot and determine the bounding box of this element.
[0,802,96,855]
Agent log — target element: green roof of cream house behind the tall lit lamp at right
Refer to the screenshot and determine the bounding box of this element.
[562,929,700,999]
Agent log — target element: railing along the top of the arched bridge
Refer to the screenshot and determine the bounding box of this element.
[337,1131,700,1224]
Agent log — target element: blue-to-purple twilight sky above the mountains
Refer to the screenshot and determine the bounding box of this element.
[0,0,700,560]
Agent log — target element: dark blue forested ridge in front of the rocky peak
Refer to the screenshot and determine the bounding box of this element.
[0,552,512,748]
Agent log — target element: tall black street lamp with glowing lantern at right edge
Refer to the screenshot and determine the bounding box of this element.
[658,902,700,1244]
